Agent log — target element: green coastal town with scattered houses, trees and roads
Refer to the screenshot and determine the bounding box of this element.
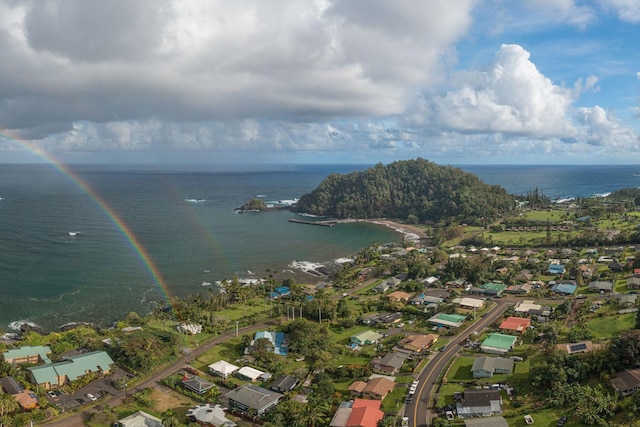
[0,194,640,427]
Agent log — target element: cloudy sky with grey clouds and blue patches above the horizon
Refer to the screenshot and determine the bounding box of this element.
[0,0,640,165]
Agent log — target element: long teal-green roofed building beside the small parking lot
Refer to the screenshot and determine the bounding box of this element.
[27,351,114,390]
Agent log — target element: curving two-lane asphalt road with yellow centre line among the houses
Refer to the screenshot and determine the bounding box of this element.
[404,299,514,427]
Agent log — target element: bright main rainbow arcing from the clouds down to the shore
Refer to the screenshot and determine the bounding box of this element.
[0,128,171,300]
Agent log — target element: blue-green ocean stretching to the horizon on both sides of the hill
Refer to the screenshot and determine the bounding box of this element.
[0,165,640,331]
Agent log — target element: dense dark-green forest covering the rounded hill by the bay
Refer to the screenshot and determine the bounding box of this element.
[296,158,515,224]
